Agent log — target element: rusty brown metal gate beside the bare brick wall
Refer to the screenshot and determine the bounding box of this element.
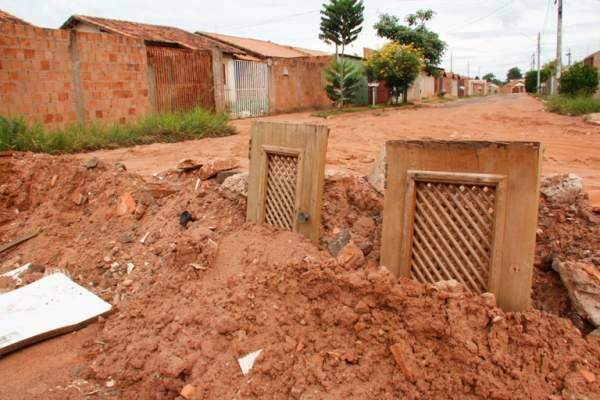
[147,46,215,113]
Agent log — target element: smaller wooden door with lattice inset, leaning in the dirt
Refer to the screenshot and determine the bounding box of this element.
[246,121,329,245]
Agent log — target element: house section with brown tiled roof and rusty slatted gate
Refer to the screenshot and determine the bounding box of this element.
[61,15,245,112]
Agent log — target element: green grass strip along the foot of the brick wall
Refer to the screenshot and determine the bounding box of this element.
[0,108,235,154]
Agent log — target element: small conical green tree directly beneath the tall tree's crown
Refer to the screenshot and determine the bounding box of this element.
[325,58,361,107]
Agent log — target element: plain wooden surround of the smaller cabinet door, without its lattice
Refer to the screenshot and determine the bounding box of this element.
[247,121,329,244]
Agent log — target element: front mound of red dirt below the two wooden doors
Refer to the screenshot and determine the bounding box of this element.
[82,226,600,399]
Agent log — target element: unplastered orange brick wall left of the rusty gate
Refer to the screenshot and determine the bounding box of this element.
[0,23,150,127]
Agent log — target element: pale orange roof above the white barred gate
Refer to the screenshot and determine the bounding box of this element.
[196,32,329,58]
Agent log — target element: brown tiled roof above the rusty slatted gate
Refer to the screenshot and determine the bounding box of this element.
[61,15,243,53]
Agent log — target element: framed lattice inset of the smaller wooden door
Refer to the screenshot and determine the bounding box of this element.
[259,145,304,231]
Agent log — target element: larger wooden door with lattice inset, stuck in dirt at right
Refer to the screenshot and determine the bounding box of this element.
[381,140,543,311]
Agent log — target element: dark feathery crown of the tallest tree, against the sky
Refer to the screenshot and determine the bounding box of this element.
[319,0,365,56]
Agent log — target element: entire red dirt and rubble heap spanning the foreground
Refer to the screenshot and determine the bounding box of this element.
[0,154,600,400]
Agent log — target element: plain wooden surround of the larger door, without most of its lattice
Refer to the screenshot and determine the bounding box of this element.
[381,140,542,311]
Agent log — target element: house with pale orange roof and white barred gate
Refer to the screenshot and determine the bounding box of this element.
[196,32,334,118]
